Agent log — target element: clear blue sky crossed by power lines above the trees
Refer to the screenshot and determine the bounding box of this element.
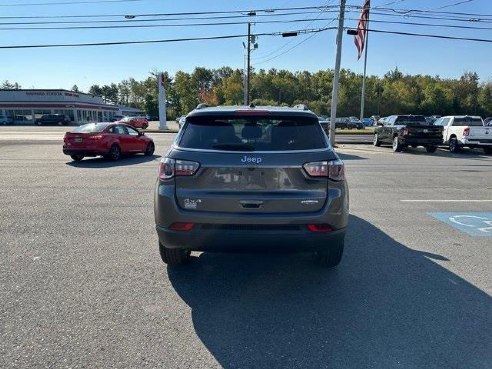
[0,0,492,91]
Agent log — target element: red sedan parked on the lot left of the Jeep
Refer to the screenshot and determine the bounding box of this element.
[63,122,155,161]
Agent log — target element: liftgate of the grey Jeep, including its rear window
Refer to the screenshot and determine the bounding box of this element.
[173,116,336,214]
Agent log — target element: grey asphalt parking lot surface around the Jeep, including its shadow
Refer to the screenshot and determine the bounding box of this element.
[0,127,492,368]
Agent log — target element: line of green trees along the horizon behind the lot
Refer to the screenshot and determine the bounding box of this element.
[2,67,492,119]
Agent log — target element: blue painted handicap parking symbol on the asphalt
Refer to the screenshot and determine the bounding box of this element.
[428,212,492,237]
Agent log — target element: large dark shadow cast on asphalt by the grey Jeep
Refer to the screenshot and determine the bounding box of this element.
[168,216,492,369]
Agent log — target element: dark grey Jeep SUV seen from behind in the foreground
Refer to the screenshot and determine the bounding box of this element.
[154,106,349,267]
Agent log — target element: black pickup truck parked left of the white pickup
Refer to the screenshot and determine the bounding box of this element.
[373,115,442,153]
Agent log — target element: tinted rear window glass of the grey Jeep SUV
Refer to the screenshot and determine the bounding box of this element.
[178,116,327,151]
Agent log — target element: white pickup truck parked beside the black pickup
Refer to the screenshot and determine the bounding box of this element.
[434,115,492,154]
